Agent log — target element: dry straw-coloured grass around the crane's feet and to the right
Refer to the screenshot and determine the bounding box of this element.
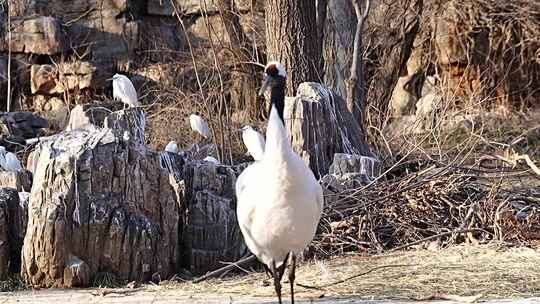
[155,244,540,299]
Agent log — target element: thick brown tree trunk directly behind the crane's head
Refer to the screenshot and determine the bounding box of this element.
[265,0,323,96]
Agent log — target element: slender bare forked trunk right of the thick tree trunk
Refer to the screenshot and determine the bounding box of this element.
[347,0,371,126]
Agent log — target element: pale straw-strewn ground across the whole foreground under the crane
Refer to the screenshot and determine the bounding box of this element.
[0,244,540,304]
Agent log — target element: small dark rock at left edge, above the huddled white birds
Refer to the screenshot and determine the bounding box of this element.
[0,112,49,138]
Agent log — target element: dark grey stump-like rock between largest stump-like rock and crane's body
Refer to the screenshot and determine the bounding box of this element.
[182,161,249,274]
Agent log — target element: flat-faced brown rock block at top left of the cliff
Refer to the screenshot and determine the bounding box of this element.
[1,16,66,55]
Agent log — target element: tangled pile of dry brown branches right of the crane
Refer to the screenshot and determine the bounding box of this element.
[313,163,540,256]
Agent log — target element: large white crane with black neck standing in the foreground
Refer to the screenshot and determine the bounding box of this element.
[236,62,323,303]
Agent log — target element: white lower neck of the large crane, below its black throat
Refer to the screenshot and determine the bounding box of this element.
[264,105,291,158]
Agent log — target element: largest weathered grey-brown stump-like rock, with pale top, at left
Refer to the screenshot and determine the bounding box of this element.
[21,114,181,287]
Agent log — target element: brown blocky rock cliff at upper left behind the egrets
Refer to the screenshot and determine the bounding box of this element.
[0,0,262,131]
